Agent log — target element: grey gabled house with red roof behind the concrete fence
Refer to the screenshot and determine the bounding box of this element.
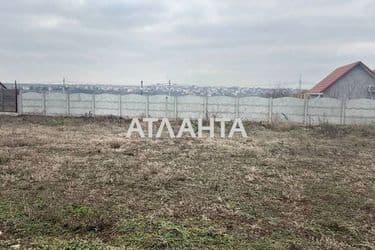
[307,62,375,99]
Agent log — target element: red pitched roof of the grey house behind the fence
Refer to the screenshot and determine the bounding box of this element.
[308,62,375,94]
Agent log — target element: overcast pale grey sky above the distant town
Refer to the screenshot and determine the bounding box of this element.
[0,0,375,88]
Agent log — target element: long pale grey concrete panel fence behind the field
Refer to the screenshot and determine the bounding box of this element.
[18,92,375,124]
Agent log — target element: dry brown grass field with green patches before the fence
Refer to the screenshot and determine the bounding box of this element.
[0,116,375,249]
